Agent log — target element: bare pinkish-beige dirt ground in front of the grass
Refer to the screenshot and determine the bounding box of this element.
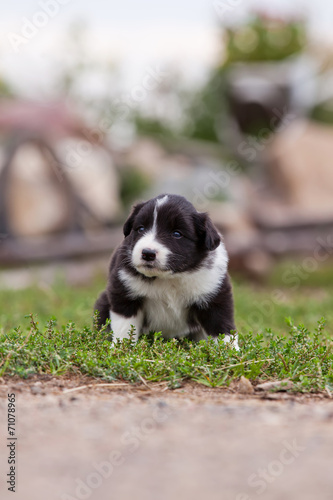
[0,376,333,500]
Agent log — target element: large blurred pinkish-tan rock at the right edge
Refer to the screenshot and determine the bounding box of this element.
[256,120,333,225]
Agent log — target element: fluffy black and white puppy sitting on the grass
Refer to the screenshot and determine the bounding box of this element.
[95,194,238,348]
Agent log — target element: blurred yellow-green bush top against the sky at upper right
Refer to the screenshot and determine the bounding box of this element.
[226,14,307,64]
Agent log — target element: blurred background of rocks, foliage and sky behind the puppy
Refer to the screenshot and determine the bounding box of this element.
[0,0,333,328]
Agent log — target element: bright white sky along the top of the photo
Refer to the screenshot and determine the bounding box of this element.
[0,0,333,94]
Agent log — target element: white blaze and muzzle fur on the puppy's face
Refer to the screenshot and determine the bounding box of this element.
[132,196,171,269]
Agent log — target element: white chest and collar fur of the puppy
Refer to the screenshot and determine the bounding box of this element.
[119,243,228,338]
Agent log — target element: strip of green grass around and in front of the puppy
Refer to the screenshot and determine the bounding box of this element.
[0,272,333,392]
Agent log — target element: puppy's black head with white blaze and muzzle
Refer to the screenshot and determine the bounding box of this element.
[124,195,221,277]
